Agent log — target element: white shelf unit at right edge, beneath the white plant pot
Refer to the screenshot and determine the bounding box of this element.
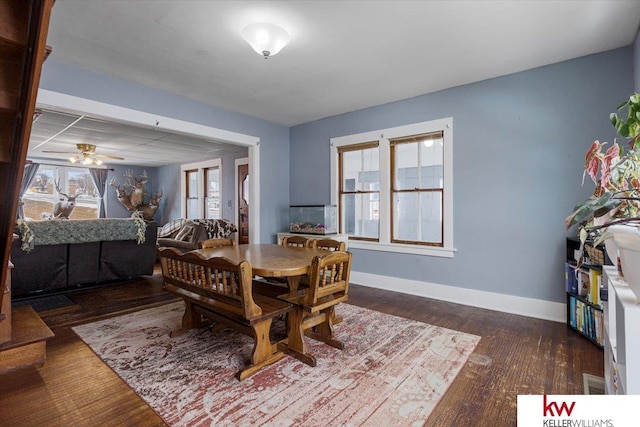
[603,266,640,394]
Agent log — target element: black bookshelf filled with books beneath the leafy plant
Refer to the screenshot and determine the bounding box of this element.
[565,238,608,348]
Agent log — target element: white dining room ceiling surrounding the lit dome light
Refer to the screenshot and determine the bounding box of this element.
[35,0,640,163]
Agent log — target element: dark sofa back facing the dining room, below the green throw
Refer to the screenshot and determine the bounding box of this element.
[11,223,158,298]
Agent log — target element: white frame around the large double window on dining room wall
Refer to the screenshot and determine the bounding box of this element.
[330,117,456,258]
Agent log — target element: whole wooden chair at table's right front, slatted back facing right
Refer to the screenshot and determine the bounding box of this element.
[278,252,351,366]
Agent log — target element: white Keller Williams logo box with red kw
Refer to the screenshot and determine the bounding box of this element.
[518,394,640,427]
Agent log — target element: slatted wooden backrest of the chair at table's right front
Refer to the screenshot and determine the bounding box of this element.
[302,251,351,309]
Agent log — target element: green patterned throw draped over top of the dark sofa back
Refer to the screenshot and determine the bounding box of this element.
[16,218,147,252]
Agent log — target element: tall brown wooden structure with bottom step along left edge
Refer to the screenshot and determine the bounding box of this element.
[0,0,53,373]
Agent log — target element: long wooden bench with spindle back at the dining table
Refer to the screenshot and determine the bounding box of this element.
[160,248,292,380]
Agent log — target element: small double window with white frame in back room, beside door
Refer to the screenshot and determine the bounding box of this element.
[181,159,222,219]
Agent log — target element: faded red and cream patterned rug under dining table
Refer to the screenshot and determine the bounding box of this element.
[73,302,480,427]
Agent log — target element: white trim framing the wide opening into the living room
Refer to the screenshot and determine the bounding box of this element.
[36,89,260,243]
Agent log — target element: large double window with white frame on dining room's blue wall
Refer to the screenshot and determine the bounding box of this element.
[331,118,454,257]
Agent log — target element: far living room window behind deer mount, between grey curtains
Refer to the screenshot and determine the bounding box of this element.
[22,164,100,220]
